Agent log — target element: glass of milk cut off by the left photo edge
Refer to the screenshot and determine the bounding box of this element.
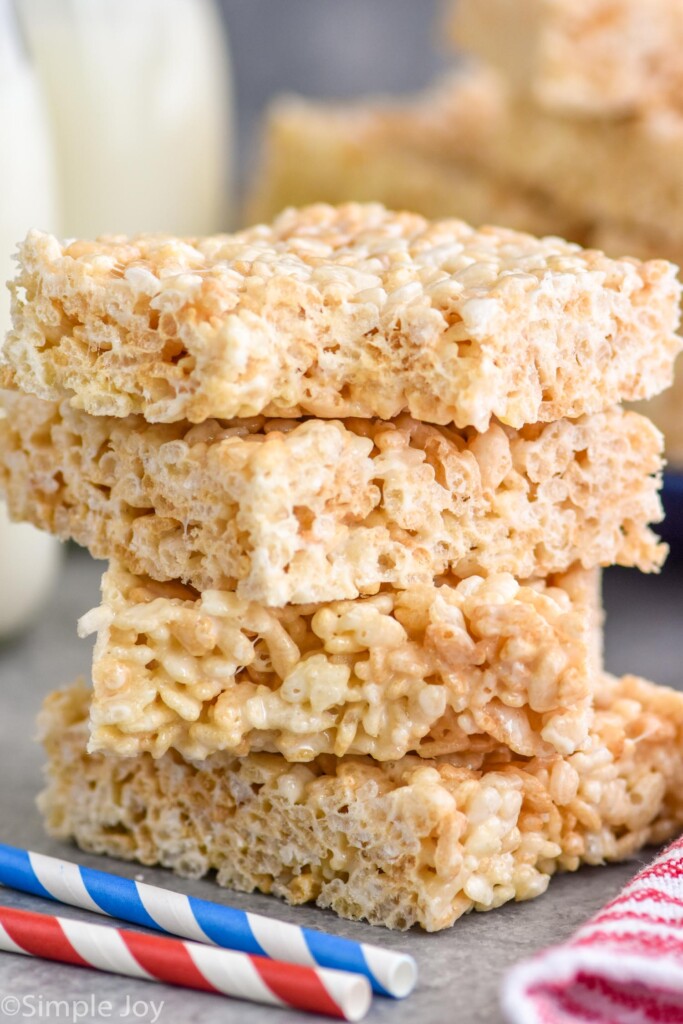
[0,0,59,639]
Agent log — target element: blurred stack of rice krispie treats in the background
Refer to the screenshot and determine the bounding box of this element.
[250,0,683,465]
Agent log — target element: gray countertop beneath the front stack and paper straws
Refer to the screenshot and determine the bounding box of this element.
[0,551,683,1024]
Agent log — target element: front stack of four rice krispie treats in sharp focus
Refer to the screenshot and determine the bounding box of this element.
[0,204,683,930]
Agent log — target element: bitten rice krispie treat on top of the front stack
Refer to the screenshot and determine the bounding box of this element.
[3,204,681,431]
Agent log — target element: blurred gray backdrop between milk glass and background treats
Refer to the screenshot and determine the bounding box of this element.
[221,0,454,184]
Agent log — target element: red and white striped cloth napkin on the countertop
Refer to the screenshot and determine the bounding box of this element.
[502,838,683,1024]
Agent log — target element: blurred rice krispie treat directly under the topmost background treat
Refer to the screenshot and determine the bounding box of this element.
[415,69,683,246]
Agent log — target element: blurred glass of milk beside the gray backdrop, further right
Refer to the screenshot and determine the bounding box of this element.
[16,0,231,238]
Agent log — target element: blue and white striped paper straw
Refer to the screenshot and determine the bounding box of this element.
[0,843,417,998]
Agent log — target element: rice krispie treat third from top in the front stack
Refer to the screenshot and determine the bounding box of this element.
[80,563,602,761]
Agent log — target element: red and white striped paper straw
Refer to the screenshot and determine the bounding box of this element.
[0,907,372,1021]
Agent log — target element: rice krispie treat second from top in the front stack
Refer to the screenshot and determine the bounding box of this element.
[0,393,666,606]
